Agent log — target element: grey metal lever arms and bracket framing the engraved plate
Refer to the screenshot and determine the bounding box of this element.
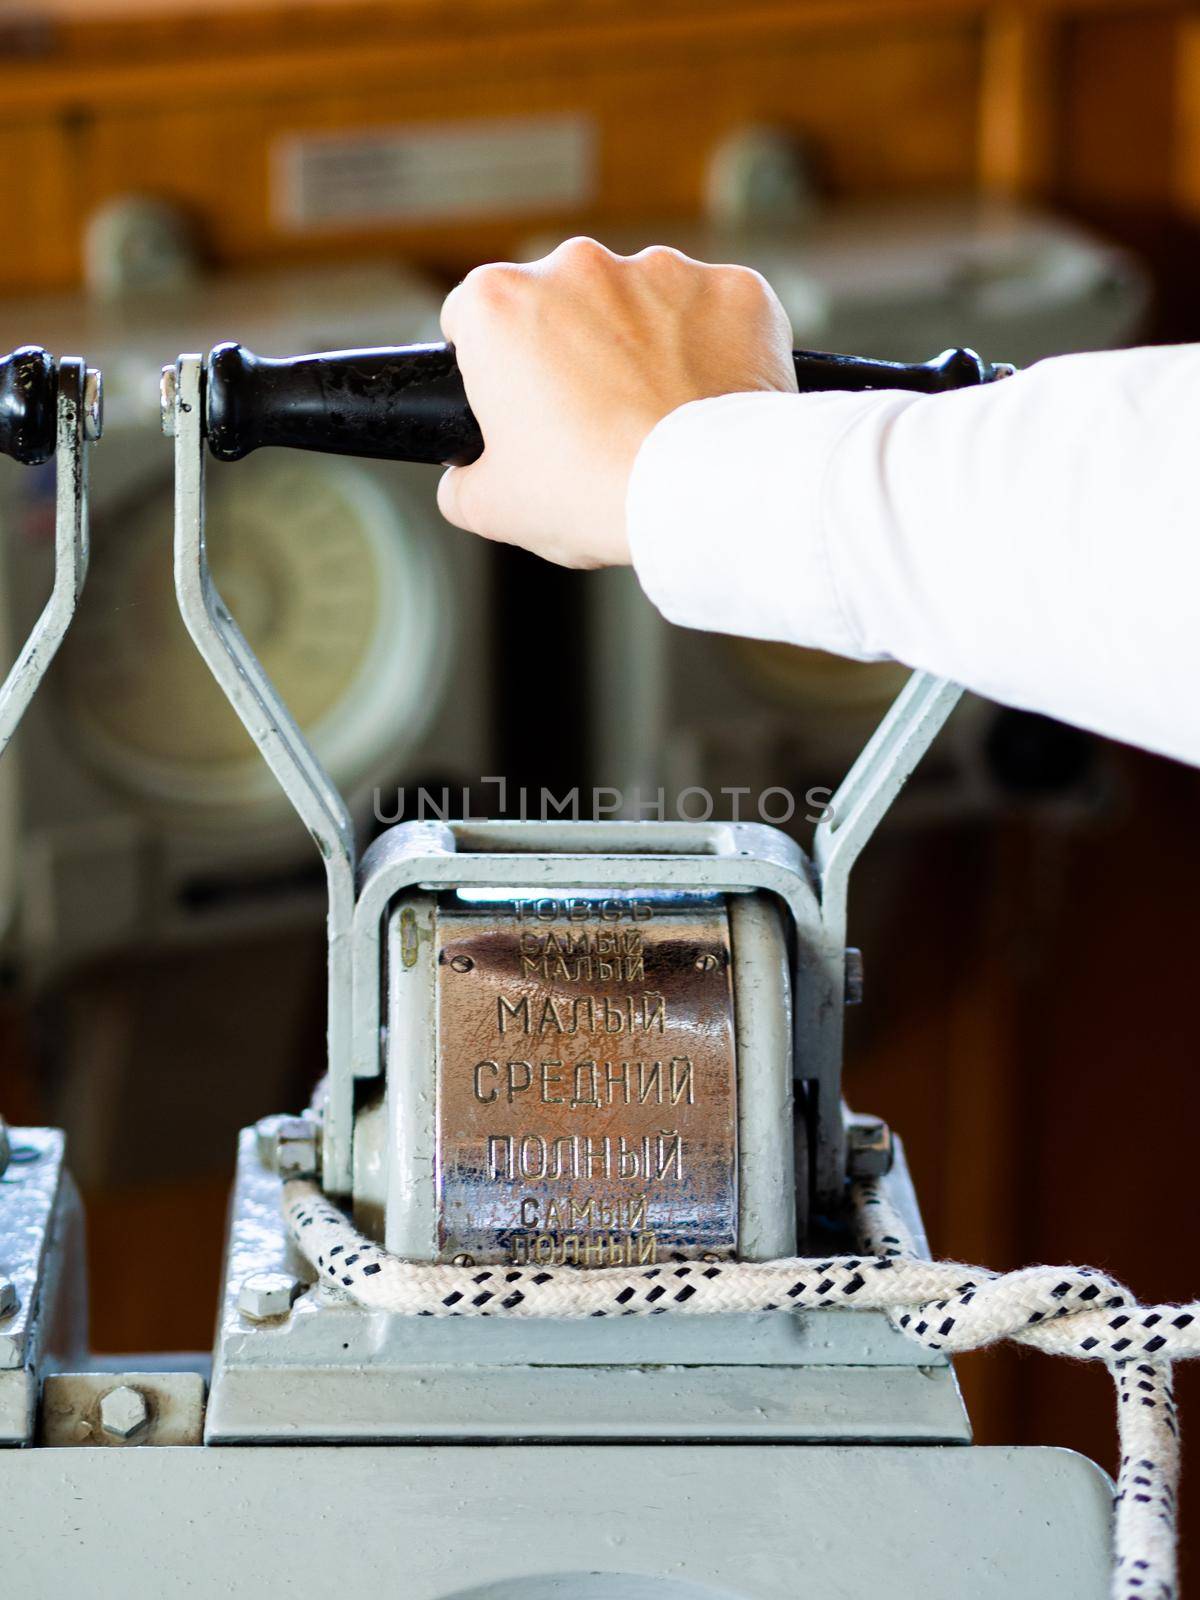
[163,355,962,1206]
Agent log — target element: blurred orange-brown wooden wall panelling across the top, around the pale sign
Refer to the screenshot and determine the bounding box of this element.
[0,0,1200,291]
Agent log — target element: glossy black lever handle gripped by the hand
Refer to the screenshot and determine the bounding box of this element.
[205,344,1006,466]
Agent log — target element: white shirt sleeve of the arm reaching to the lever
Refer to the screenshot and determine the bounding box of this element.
[627,346,1200,765]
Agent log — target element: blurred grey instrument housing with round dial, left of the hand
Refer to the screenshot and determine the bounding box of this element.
[0,248,494,970]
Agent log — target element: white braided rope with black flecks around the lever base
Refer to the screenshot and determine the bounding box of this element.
[283,1179,1200,1600]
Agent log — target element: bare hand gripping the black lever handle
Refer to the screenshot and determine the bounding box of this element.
[438,238,795,566]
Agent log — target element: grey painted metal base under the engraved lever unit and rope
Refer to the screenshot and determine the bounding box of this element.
[205,1131,971,1445]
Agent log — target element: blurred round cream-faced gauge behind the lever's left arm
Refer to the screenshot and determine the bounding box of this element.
[59,454,450,826]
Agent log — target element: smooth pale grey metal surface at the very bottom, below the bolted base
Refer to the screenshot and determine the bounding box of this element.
[0,1445,1110,1600]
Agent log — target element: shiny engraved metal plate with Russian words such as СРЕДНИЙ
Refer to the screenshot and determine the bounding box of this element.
[435,894,738,1266]
